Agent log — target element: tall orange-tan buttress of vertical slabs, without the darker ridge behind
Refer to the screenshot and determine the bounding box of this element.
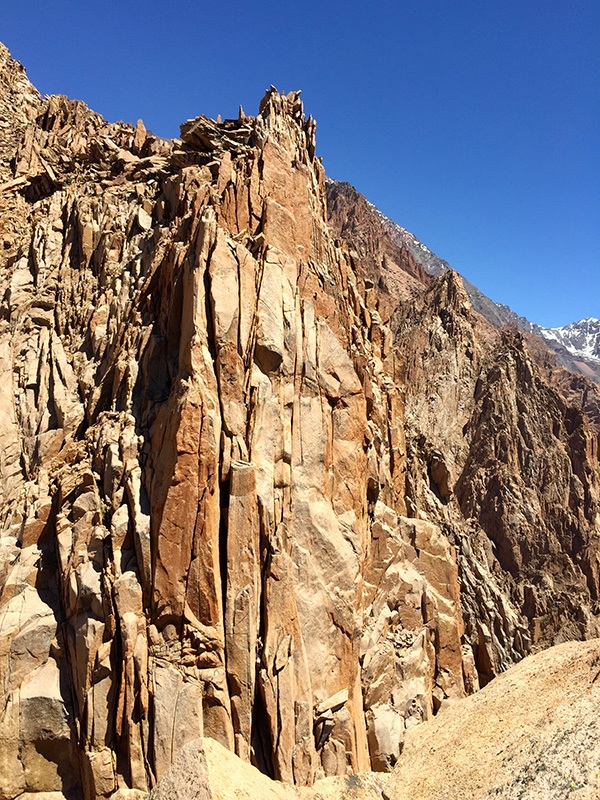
[1,50,462,797]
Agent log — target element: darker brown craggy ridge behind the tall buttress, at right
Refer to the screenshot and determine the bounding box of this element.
[396,273,599,664]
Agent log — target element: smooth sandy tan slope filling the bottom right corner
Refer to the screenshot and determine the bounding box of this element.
[386,640,600,800]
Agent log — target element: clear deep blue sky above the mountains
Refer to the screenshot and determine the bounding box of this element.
[0,0,600,326]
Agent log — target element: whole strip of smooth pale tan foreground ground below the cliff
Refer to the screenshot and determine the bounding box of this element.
[126,640,600,800]
